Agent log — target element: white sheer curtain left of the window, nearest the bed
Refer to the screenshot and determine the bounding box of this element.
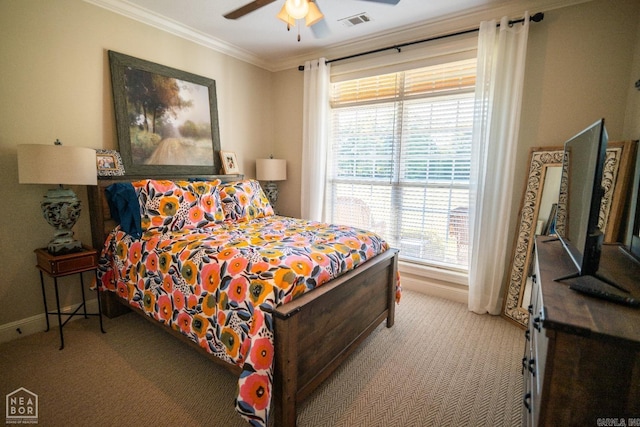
[300,58,330,221]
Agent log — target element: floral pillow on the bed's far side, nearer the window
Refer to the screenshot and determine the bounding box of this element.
[219,179,274,222]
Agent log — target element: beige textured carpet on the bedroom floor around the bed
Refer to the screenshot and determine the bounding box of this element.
[0,291,524,427]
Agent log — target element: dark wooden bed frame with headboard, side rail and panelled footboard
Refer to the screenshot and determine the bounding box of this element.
[88,175,398,427]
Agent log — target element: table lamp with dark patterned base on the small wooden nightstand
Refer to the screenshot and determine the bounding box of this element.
[17,139,98,255]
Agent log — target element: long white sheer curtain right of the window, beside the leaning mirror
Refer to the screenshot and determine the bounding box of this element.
[469,13,529,314]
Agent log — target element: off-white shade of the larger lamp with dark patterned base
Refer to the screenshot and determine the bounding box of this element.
[18,144,98,185]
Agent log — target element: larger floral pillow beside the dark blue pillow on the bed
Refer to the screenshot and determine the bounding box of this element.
[133,179,224,233]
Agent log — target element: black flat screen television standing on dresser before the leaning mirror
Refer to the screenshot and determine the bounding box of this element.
[556,119,608,280]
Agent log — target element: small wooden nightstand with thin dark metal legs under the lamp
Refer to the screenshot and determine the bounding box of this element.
[34,246,105,350]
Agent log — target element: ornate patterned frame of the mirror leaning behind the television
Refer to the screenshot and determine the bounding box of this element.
[502,141,637,328]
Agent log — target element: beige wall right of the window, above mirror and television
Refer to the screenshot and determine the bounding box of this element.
[507,0,640,294]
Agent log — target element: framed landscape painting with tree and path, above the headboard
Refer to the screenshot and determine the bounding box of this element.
[109,51,221,175]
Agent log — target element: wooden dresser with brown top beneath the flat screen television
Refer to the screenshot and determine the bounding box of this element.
[522,236,640,426]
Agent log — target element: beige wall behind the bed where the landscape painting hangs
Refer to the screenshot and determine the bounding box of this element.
[0,0,274,326]
